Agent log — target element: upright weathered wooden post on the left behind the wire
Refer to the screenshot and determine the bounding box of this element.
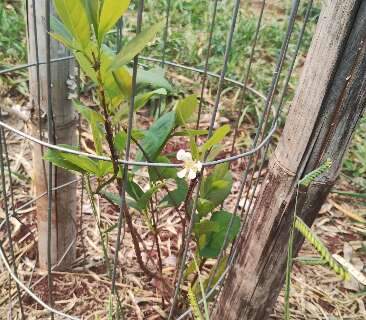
[28,0,77,269]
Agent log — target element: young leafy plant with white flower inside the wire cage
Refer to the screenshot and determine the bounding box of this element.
[45,0,240,306]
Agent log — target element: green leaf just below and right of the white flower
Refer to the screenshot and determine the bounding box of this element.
[200,163,233,206]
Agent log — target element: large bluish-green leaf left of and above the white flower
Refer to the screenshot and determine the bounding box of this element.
[138,111,175,161]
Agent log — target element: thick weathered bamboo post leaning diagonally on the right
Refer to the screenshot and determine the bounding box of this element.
[212,0,366,320]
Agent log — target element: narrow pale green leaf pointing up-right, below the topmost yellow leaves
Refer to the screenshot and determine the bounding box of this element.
[110,22,163,71]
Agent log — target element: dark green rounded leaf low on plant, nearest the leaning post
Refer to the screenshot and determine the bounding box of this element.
[199,211,240,258]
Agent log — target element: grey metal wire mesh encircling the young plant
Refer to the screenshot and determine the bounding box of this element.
[0,0,313,319]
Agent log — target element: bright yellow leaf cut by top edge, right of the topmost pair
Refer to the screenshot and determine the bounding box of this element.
[98,0,130,43]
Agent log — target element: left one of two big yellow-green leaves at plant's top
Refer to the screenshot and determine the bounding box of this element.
[53,0,90,48]
